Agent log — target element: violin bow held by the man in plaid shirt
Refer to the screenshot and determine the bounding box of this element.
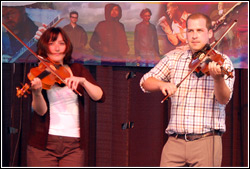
[161,20,237,103]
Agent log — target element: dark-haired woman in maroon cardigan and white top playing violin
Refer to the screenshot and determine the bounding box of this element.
[27,27,105,167]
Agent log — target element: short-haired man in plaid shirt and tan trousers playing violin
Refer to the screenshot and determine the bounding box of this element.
[140,13,235,167]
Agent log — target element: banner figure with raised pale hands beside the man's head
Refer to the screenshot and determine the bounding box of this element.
[158,2,190,49]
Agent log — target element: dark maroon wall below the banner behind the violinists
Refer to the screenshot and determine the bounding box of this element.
[2,64,248,167]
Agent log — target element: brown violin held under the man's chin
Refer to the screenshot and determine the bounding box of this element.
[189,44,233,78]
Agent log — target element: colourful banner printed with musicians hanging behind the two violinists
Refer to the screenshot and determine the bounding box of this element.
[1,1,248,68]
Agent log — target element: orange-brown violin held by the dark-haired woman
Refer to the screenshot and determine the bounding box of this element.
[16,62,73,98]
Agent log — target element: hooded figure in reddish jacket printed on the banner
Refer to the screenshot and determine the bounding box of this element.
[89,3,129,62]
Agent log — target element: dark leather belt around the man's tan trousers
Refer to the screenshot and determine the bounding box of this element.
[170,130,222,141]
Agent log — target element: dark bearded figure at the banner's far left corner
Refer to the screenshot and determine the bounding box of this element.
[2,2,38,62]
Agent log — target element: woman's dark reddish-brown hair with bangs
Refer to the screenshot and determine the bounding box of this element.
[37,27,73,64]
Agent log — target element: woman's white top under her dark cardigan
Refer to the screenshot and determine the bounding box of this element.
[47,85,80,137]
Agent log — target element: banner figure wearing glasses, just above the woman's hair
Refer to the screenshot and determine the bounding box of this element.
[63,11,88,61]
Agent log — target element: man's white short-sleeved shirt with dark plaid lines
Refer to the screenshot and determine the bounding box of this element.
[140,49,235,134]
